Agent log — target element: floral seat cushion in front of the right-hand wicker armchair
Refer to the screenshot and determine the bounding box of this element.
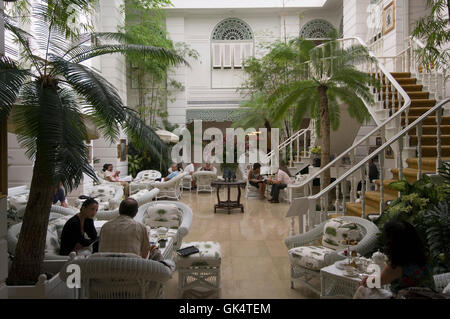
[288,246,334,270]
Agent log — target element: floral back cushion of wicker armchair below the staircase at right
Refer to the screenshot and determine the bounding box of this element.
[322,217,363,249]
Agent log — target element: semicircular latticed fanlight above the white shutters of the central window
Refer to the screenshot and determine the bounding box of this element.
[212,18,253,41]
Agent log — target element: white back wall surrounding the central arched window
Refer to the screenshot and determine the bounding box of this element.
[166,8,342,124]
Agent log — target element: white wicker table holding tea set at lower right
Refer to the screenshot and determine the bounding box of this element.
[320,264,363,298]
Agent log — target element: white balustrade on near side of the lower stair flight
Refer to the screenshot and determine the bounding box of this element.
[300,98,450,232]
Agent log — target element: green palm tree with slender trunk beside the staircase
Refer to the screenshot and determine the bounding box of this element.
[269,38,377,188]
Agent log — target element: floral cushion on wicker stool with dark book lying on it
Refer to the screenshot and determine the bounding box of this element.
[175,241,222,268]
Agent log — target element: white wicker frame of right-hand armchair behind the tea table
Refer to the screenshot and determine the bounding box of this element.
[285,216,379,294]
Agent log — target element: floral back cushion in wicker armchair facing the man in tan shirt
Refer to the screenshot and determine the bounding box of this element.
[143,204,182,228]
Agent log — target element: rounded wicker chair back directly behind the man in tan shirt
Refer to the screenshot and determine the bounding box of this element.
[59,253,173,299]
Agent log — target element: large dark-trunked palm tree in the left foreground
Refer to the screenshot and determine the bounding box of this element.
[0,0,186,284]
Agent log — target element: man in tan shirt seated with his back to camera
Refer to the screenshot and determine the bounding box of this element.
[98,198,173,267]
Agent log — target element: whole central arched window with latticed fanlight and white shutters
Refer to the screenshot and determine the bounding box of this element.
[211,18,253,69]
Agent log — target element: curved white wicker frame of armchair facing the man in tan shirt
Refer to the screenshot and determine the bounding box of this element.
[134,200,192,249]
